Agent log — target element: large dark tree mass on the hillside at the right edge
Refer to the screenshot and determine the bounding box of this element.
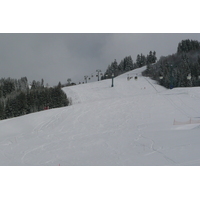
[143,39,200,88]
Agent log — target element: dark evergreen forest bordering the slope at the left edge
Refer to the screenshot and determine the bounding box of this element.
[0,77,69,120]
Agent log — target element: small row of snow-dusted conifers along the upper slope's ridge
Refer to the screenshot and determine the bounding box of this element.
[101,51,157,80]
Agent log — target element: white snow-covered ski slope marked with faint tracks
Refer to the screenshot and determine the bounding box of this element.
[0,67,200,166]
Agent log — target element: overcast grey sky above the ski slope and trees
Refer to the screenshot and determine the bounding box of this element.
[0,33,200,85]
